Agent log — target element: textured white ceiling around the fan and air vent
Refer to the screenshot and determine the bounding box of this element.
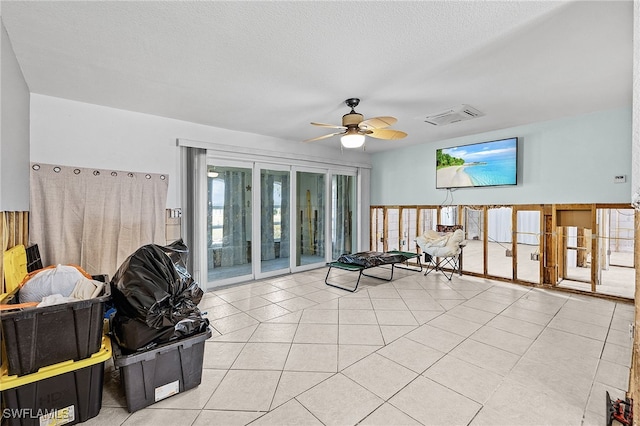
[1,1,633,152]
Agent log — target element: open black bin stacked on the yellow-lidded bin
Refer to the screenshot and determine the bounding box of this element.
[2,275,111,376]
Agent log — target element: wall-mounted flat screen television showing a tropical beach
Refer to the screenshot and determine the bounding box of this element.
[436,138,518,189]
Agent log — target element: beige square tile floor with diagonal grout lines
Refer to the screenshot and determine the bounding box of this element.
[85,268,634,426]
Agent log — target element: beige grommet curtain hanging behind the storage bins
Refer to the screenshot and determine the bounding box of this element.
[29,163,169,277]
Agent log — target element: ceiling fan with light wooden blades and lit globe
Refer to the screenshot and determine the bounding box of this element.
[304,98,407,148]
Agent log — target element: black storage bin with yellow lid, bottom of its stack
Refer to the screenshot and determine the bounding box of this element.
[0,337,112,426]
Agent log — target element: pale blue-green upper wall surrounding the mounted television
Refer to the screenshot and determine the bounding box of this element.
[371,108,632,205]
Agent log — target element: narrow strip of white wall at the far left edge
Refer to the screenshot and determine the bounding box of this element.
[0,22,29,211]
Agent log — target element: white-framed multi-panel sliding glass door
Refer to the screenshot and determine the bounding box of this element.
[200,154,358,289]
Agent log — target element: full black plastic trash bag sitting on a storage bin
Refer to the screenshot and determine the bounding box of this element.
[111,240,209,350]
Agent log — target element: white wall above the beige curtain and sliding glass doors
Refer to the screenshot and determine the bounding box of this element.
[31,94,369,208]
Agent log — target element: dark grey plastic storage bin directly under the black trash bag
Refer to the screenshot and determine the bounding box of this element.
[113,328,211,413]
